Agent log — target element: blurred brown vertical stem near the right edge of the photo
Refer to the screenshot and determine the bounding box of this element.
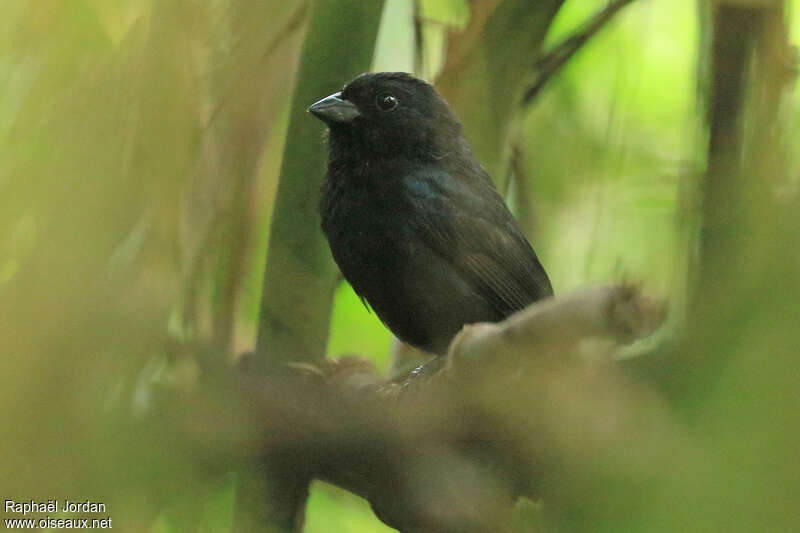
[654,1,788,408]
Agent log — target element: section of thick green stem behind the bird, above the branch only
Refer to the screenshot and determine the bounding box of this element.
[256,0,382,366]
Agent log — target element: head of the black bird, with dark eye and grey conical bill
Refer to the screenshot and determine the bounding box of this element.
[308,72,461,159]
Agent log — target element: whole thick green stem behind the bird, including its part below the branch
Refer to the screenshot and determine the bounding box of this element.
[234,0,383,533]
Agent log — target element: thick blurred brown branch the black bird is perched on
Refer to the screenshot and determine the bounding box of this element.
[208,287,676,533]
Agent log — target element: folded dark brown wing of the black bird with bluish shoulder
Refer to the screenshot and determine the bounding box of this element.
[406,168,553,316]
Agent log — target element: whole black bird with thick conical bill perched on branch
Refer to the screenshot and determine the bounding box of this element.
[308,72,553,353]
